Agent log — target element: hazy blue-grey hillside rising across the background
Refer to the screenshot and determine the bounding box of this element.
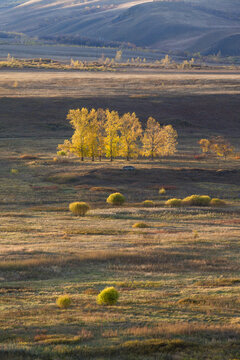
[0,0,240,55]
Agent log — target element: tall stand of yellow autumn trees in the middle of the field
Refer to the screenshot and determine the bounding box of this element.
[58,108,178,161]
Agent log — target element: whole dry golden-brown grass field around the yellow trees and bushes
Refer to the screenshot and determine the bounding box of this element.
[0,72,240,360]
